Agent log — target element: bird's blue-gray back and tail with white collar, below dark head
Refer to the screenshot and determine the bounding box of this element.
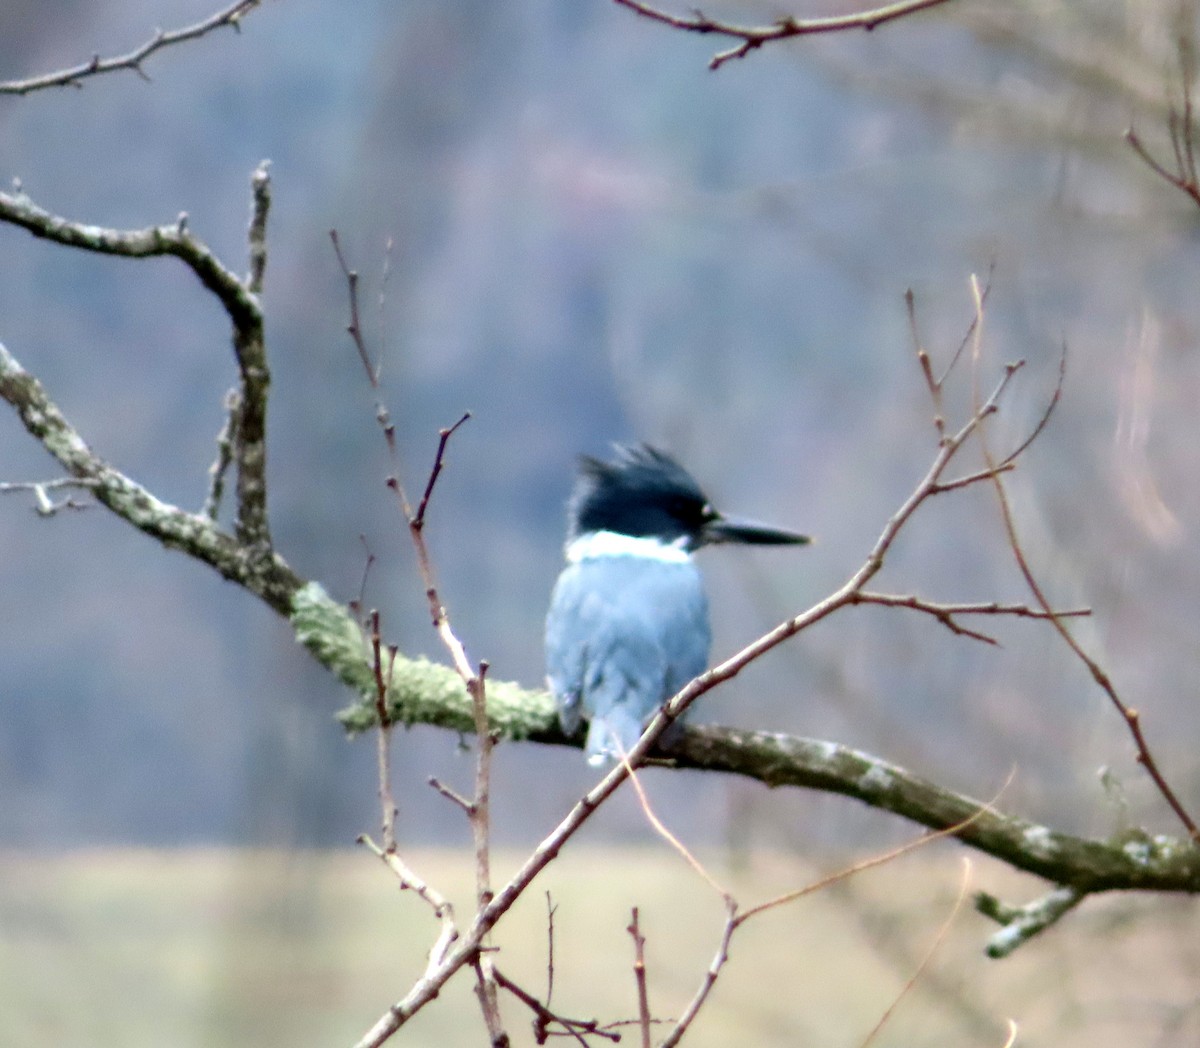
[546,532,712,765]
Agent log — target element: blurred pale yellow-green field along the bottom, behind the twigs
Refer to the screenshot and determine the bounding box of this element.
[0,845,1200,1048]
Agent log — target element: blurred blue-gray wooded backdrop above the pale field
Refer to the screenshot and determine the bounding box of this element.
[0,0,1200,1043]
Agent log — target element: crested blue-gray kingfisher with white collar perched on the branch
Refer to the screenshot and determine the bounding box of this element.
[546,444,809,767]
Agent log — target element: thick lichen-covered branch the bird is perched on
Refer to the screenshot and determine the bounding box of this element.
[0,336,1200,907]
